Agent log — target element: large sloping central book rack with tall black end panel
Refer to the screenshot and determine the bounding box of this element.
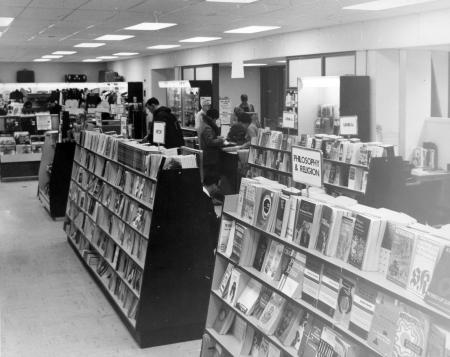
[65,132,214,347]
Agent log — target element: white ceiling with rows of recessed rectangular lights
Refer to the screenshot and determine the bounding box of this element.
[0,0,450,62]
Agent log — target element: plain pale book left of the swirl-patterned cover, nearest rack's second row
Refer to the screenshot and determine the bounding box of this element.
[368,293,400,356]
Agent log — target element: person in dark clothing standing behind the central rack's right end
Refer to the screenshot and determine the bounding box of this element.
[198,109,224,176]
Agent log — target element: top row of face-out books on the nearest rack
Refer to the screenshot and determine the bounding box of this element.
[230,178,450,314]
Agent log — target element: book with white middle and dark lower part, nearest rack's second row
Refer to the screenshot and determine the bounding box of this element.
[348,280,377,340]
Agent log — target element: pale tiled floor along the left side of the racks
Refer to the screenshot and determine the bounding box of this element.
[0,181,200,357]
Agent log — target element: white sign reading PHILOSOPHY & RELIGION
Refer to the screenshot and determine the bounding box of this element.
[292,146,322,187]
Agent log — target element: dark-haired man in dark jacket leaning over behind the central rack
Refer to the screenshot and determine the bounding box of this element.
[145,97,184,149]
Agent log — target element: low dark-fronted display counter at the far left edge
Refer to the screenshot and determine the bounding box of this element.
[0,153,41,181]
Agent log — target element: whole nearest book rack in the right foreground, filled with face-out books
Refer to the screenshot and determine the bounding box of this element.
[201,179,450,357]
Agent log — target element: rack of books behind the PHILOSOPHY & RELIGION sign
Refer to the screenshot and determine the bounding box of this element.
[248,129,405,208]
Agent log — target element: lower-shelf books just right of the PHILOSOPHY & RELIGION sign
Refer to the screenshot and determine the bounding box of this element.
[323,161,369,192]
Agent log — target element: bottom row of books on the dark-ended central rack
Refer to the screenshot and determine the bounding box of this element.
[65,217,139,322]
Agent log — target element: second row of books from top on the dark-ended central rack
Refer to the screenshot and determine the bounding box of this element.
[76,149,156,207]
